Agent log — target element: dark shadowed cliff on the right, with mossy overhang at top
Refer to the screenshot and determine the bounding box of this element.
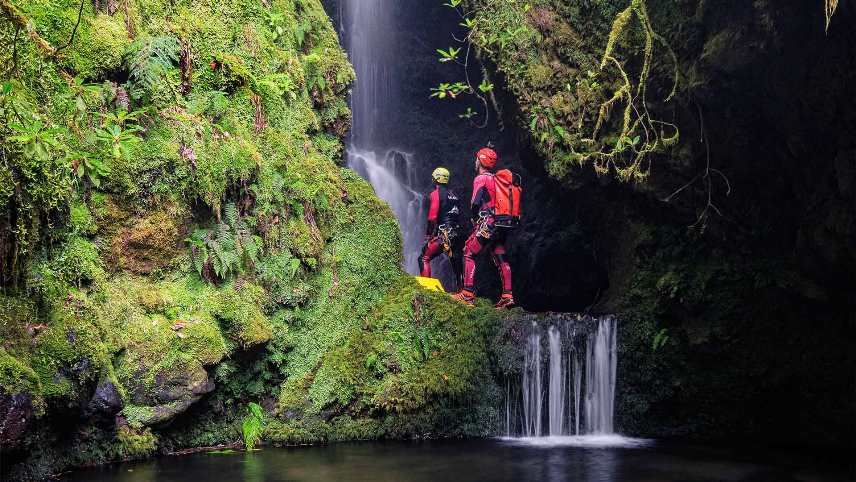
[466,0,856,444]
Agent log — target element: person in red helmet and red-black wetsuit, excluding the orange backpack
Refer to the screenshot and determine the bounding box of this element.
[455,147,515,308]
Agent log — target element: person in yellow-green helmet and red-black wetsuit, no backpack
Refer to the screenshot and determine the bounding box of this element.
[419,167,461,289]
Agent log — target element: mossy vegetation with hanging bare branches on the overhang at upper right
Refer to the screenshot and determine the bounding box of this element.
[432,0,680,182]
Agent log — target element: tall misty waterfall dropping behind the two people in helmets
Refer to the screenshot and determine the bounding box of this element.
[339,0,427,274]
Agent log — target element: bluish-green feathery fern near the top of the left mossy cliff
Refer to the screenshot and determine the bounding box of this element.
[124,35,181,99]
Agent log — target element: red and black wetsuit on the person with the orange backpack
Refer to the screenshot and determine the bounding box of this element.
[464,172,512,295]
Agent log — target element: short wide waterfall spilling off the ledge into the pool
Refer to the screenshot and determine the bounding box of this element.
[506,315,617,437]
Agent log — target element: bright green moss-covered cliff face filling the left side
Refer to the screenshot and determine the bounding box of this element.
[0,0,504,480]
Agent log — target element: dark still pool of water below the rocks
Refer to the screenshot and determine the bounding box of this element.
[62,440,847,482]
